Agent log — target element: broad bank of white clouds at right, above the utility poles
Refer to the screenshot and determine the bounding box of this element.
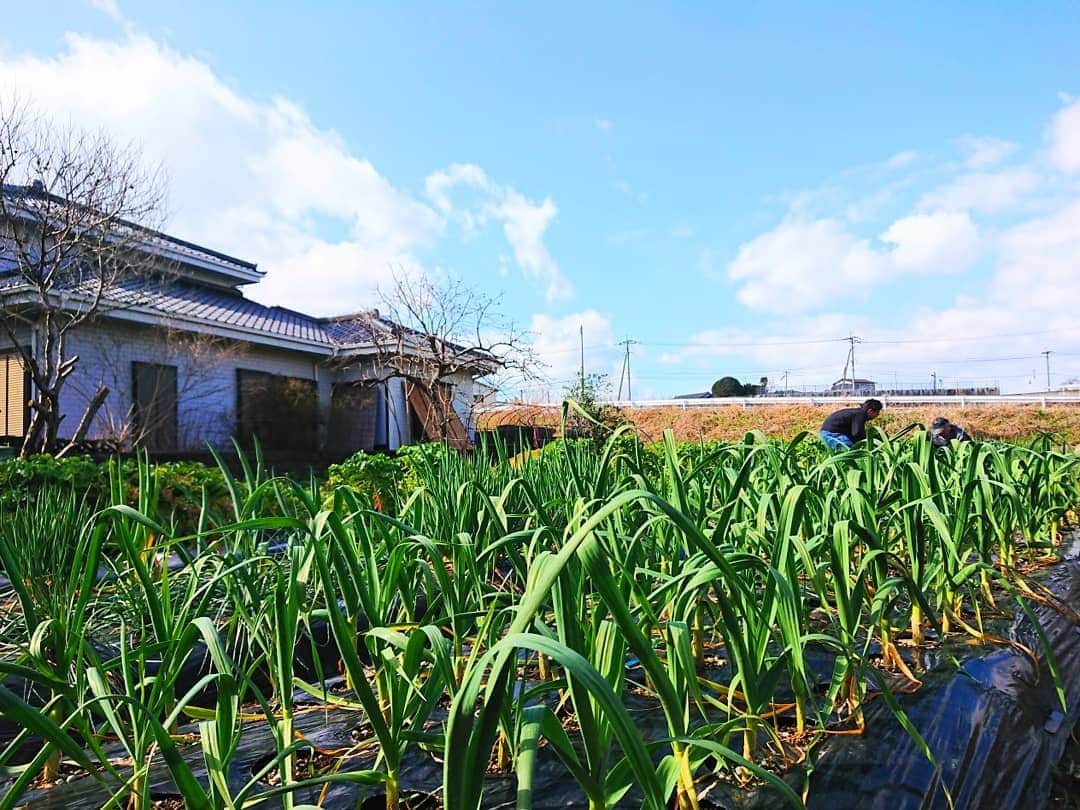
[695,98,1080,391]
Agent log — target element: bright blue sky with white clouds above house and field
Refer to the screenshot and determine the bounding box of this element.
[0,0,1080,397]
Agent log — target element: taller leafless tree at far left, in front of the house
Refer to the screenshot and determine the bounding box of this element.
[0,102,165,456]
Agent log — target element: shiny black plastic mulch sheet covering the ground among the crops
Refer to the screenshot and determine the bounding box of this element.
[8,561,1080,810]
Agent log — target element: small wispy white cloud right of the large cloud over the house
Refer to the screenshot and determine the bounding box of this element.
[424,163,573,300]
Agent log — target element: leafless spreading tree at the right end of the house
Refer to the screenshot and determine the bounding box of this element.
[341,271,538,447]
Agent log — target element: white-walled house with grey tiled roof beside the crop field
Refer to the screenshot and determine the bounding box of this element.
[0,187,497,456]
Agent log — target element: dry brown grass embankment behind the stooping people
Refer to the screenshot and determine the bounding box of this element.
[622,403,1080,445]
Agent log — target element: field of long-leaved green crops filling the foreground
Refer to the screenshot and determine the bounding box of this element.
[0,430,1080,808]
